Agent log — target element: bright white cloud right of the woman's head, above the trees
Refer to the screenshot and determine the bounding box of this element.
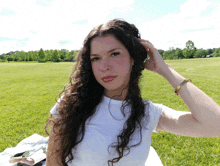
[138,0,220,50]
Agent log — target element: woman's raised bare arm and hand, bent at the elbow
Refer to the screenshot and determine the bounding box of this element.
[140,39,220,137]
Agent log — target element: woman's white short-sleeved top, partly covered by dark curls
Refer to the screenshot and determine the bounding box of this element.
[50,96,170,166]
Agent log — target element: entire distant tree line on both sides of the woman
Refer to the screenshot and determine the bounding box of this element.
[0,40,220,62]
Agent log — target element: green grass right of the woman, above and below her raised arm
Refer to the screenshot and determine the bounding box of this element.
[140,58,220,166]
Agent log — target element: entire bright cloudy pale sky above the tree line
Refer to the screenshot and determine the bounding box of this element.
[0,0,220,54]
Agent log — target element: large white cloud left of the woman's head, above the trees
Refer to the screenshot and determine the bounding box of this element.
[0,0,133,54]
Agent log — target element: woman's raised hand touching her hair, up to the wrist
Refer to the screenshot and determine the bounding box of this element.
[140,39,168,75]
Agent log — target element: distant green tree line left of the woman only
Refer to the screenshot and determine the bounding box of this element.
[0,48,78,62]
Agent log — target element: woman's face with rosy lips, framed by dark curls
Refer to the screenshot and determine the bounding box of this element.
[90,35,134,100]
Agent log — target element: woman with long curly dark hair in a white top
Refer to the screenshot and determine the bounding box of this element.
[47,19,220,166]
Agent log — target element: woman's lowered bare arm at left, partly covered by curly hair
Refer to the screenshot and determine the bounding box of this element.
[46,115,62,166]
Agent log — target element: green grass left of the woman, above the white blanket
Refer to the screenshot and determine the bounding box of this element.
[0,62,73,152]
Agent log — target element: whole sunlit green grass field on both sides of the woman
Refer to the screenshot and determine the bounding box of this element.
[0,58,220,166]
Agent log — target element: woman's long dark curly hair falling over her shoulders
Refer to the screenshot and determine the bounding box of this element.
[45,19,147,166]
